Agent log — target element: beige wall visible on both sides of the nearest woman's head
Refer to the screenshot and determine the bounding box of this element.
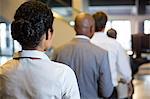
[0,0,75,47]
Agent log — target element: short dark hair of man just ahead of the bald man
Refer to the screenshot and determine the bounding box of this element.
[93,12,108,32]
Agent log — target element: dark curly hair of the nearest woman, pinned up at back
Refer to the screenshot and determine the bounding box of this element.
[11,1,54,48]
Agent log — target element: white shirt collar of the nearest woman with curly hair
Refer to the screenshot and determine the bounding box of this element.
[13,50,50,60]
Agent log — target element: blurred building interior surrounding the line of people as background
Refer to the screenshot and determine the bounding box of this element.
[0,0,150,99]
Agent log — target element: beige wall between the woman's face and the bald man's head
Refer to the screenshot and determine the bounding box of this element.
[52,18,75,48]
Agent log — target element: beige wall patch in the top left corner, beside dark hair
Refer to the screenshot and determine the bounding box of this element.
[0,0,27,22]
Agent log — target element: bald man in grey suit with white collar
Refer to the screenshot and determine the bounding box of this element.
[53,13,113,99]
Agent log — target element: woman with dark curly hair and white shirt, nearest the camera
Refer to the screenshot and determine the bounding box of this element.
[0,1,80,99]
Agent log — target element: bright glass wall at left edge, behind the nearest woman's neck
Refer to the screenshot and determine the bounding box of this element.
[0,23,21,65]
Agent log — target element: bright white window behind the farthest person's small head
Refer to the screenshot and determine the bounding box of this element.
[106,20,131,50]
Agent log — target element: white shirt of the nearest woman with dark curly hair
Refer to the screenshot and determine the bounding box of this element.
[0,50,80,99]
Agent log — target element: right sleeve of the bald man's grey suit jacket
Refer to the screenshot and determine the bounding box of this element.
[98,53,113,97]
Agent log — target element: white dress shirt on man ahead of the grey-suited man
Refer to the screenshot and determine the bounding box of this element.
[91,32,132,86]
